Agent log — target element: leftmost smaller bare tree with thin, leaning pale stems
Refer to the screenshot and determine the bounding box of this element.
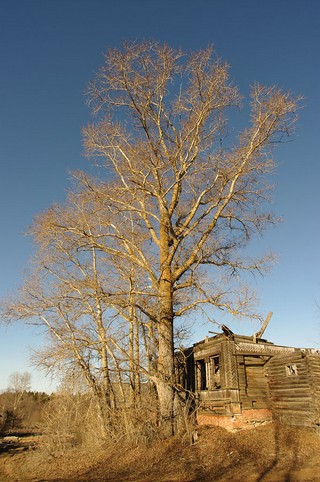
[4,191,124,434]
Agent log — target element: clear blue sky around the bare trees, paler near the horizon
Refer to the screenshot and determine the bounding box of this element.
[0,0,320,390]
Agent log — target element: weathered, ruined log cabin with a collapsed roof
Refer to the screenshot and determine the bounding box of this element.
[180,327,320,433]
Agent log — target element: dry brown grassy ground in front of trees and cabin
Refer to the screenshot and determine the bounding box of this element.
[0,424,320,482]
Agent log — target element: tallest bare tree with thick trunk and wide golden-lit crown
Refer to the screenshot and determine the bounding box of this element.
[84,42,297,435]
